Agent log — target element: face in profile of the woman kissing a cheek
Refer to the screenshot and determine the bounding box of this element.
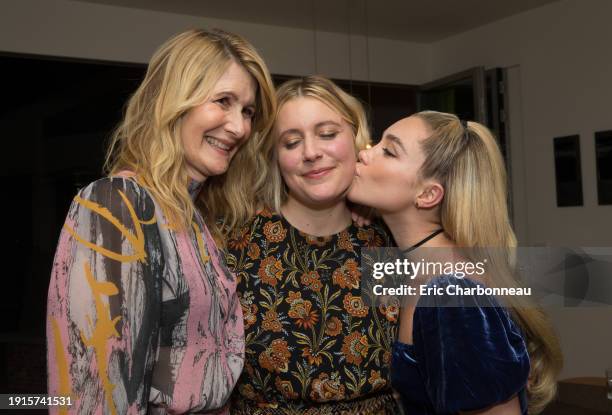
[348,117,429,213]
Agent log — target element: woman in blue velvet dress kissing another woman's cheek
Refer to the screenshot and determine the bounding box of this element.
[348,111,562,414]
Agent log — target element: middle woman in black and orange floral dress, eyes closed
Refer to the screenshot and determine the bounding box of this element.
[227,76,398,415]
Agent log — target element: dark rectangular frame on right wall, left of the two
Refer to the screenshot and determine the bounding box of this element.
[553,135,583,207]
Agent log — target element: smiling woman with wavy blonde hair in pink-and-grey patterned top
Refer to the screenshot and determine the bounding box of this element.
[47,30,275,414]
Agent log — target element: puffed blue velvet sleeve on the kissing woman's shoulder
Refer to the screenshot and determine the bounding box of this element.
[413,276,530,412]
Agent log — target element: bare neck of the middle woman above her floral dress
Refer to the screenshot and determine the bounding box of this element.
[281,195,352,236]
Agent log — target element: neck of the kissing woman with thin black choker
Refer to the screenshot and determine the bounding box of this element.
[382,209,450,249]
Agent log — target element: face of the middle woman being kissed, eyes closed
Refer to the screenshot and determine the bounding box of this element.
[275,97,357,208]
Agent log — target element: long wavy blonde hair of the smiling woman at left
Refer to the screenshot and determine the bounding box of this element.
[105,29,276,242]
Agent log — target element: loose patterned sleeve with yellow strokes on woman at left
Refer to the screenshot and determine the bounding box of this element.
[47,178,164,414]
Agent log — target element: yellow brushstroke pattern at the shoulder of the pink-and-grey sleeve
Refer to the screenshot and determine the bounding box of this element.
[64,190,156,262]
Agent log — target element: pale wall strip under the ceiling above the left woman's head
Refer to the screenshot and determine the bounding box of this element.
[0,0,430,84]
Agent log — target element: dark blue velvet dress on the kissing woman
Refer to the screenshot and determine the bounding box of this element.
[391,276,530,415]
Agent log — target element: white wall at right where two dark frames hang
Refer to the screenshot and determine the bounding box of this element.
[431,0,612,378]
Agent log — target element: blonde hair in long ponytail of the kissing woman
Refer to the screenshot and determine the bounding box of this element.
[415,111,563,414]
